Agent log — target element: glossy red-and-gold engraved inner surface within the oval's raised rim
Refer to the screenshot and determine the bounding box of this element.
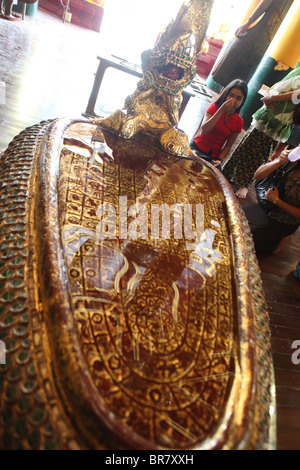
[60,140,235,448]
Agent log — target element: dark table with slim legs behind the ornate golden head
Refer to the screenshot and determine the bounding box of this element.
[83,55,195,119]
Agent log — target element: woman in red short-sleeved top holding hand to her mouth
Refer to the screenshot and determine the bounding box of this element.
[190,79,248,167]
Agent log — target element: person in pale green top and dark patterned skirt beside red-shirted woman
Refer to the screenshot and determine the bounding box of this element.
[222,62,300,198]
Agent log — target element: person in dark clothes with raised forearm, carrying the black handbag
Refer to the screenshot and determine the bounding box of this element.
[242,150,300,254]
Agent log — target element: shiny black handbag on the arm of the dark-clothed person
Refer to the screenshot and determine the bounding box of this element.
[255,161,299,213]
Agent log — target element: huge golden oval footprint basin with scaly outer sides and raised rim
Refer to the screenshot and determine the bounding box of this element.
[0,119,274,450]
